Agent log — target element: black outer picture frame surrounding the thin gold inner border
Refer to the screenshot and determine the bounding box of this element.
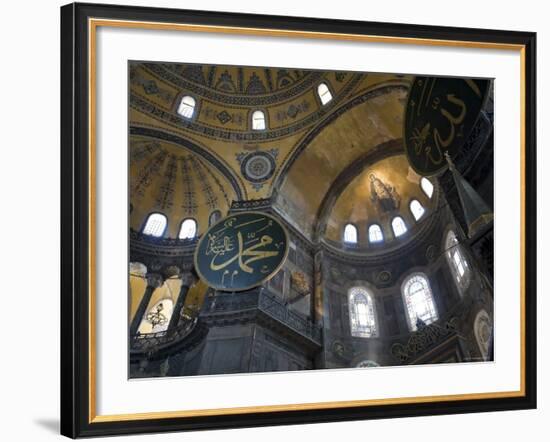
[61,3,537,438]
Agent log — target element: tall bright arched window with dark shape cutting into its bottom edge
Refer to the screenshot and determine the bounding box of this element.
[401,273,438,331]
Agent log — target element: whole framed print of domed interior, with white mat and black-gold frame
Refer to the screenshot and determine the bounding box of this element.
[61,4,536,438]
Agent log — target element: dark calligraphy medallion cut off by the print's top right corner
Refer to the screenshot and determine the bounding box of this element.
[404,77,489,176]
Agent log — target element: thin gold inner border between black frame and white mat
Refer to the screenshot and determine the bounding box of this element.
[88,18,526,423]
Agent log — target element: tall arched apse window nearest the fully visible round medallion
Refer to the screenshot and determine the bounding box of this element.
[348,287,378,338]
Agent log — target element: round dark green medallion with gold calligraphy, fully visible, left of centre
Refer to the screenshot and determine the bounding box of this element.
[195,212,288,292]
